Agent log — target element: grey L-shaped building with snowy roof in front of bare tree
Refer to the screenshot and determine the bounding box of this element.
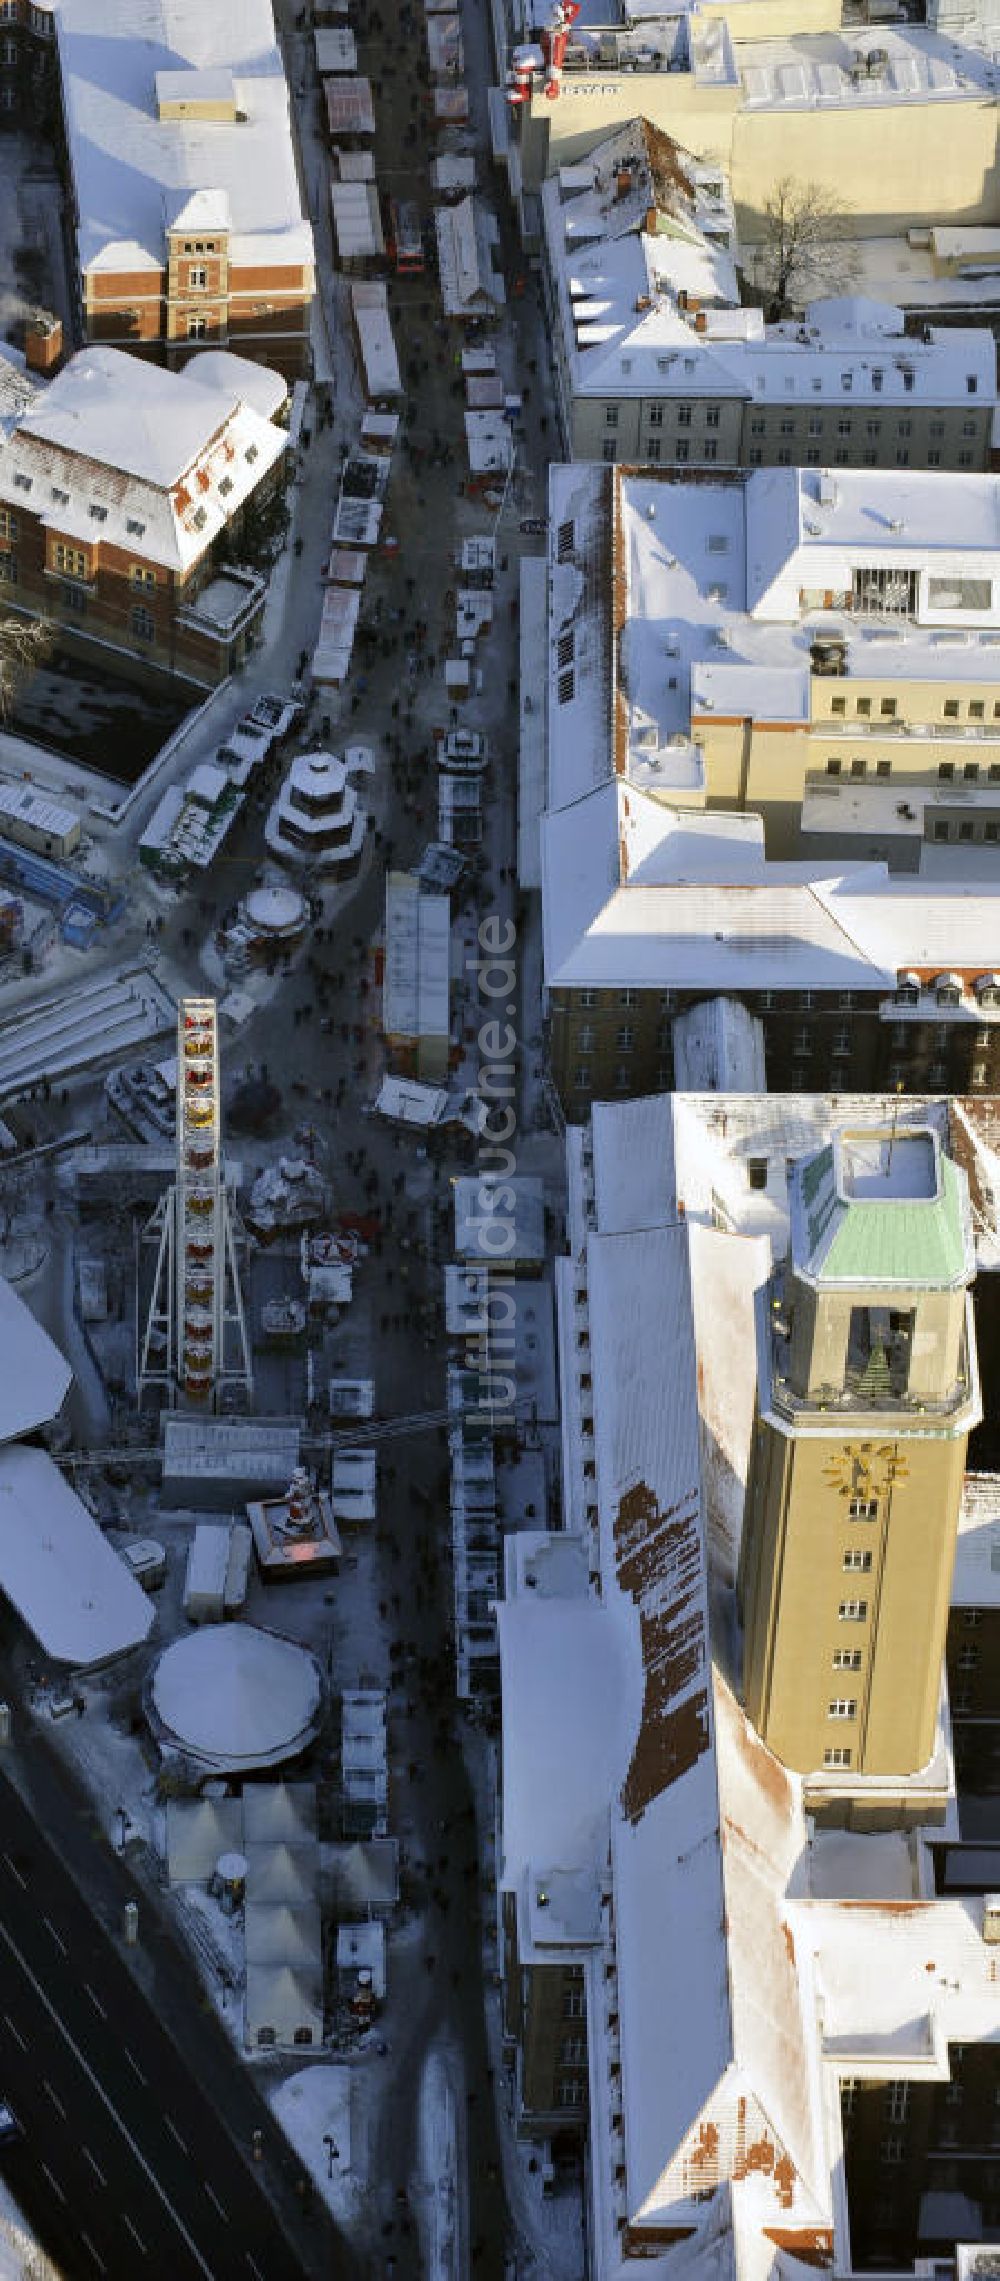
[541,119,995,470]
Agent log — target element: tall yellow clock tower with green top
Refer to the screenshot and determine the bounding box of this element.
[740,1125,979,1797]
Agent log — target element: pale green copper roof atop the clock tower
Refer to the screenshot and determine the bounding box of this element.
[792,1134,975,1289]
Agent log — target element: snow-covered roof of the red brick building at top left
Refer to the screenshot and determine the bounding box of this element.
[55,0,313,274]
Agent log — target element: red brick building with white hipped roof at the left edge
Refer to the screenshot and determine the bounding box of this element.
[0,349,288,687]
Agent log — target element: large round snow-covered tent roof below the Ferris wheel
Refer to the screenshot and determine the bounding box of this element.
[151,1624,322,1772]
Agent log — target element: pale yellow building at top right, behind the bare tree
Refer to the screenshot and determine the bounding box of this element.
[507,17,1000,242]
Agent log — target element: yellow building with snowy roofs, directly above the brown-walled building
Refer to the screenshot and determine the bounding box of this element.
[546,458,1000,871]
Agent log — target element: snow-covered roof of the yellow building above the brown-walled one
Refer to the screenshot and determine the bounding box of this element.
[548,463,1000,807]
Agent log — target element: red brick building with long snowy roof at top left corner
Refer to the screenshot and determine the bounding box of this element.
[57,0,315,376]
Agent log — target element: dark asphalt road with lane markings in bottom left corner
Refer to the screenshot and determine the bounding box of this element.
[0,1770,347,2281]
